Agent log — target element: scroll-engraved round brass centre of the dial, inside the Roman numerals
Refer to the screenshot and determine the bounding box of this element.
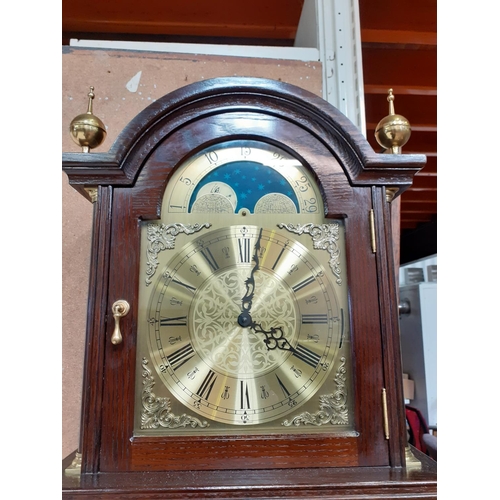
[189,265,299,378]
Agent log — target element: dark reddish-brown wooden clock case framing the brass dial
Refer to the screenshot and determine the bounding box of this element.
[63,78,435,498]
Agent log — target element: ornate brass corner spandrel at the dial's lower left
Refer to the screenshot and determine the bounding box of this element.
[141,358,210,429]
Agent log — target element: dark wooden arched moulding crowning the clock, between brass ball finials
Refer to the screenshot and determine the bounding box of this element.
[63,77,426,201]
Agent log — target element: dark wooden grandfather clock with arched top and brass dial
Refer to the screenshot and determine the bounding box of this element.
[63,78,436,499]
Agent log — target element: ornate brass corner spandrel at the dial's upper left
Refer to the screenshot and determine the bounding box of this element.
[146,222,211,286]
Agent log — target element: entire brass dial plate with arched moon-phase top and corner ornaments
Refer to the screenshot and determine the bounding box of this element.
[135,141,353,435]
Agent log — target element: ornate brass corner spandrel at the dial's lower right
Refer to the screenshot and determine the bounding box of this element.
[282,357,349,427]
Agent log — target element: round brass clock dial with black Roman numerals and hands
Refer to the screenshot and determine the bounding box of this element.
[148,225,341,425]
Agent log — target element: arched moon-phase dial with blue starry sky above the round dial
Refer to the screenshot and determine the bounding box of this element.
[163,140,322,215]
